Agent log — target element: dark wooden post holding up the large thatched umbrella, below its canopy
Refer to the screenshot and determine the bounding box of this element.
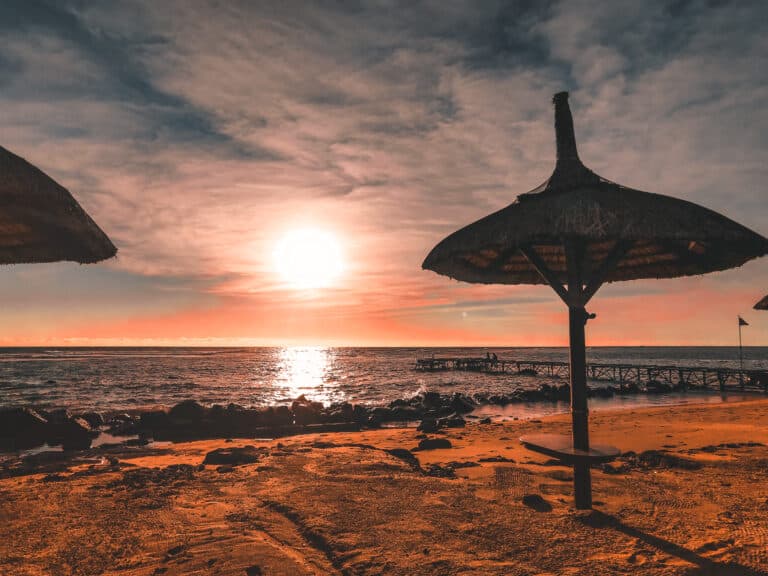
[568,307,592,510]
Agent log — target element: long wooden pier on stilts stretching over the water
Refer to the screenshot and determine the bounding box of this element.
[415,357,768,392]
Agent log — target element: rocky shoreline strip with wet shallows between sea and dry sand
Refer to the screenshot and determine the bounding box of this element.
[0,384,765,454]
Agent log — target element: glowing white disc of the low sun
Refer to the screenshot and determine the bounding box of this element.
[274,228,344,290]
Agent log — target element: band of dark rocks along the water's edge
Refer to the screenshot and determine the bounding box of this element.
[0,382,720,451]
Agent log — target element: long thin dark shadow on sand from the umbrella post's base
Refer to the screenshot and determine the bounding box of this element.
[581,510,768,576]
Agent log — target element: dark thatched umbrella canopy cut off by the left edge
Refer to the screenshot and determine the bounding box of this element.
[0,146,117,264]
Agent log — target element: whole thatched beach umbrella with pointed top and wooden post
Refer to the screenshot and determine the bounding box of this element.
[422,92,768,508]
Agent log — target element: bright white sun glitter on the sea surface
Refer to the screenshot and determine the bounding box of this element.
[277,346,341,404]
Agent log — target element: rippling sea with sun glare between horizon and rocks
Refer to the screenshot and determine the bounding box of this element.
[0,347,768,415]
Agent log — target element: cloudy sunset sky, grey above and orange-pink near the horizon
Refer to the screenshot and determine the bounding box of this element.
[0,0,768,346]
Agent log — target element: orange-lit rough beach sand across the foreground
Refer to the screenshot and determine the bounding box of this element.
[0,400,768,576]
